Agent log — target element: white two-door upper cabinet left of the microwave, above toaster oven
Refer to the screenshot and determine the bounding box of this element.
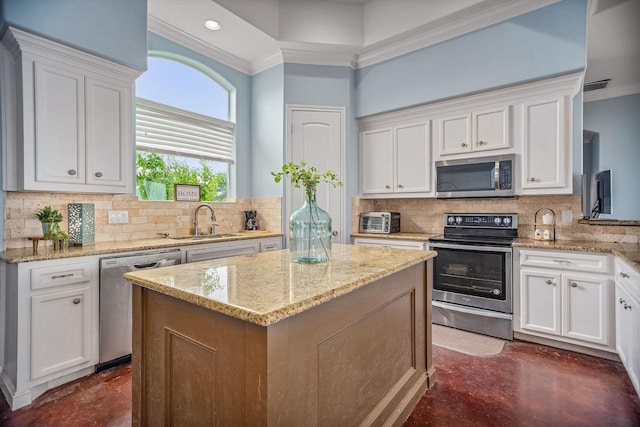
[360,121,431,195]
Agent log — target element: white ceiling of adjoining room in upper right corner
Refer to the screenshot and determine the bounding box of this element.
[584,0,640,102]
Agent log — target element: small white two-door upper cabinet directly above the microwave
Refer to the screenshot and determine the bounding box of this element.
[438,105,510,156]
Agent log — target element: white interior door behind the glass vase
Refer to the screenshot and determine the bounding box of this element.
[286,106,345,243]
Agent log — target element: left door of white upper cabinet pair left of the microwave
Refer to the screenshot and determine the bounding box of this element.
[360,129,394,193]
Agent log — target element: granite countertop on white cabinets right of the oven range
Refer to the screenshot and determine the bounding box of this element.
[513,238,640,273]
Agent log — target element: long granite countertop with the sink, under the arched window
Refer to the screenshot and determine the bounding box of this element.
[0,230,282,264]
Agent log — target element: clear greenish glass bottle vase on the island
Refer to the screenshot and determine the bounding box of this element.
[289,188,331,263]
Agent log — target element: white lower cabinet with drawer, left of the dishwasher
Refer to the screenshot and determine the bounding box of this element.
[0,257,99,410]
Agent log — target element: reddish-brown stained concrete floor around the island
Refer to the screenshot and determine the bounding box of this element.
[0,341,640,427]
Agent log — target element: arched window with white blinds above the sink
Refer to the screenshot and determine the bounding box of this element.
[136,56,234,201]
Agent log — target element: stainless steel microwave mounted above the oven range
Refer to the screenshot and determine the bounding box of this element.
[436,154,516,199]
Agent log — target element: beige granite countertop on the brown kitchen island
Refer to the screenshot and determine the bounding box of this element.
[124,245,436,326]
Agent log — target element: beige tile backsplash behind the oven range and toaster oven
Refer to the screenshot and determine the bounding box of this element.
[351,196,640,244]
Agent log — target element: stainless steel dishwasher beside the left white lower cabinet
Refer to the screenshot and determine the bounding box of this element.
[96,249,182,371]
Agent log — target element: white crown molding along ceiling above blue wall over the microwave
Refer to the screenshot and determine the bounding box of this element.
[357,0,559,68]
